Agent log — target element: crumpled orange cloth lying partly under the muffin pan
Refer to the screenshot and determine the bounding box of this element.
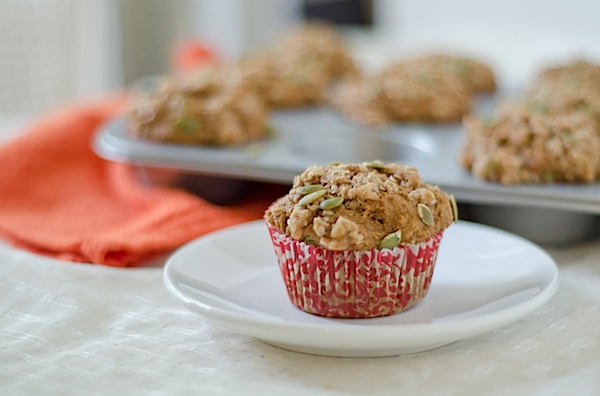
[0,98,283,267]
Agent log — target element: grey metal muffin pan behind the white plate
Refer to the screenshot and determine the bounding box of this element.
[93,99,600,244]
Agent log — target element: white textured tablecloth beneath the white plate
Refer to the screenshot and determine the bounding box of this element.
[0,235,600,396]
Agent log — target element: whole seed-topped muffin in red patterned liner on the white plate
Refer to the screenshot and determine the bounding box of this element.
[264,161,458,318]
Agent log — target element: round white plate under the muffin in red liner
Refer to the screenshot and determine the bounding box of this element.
[164,221,558,357]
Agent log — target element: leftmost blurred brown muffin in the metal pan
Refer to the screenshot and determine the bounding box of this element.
[128,66,268,146]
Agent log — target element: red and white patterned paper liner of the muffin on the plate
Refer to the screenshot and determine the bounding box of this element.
[267,223,443,318]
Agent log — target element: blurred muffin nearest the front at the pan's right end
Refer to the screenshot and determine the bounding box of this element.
[460,104,600,184]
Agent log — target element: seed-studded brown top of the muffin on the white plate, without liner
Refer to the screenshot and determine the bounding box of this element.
[265,161,457,250]
